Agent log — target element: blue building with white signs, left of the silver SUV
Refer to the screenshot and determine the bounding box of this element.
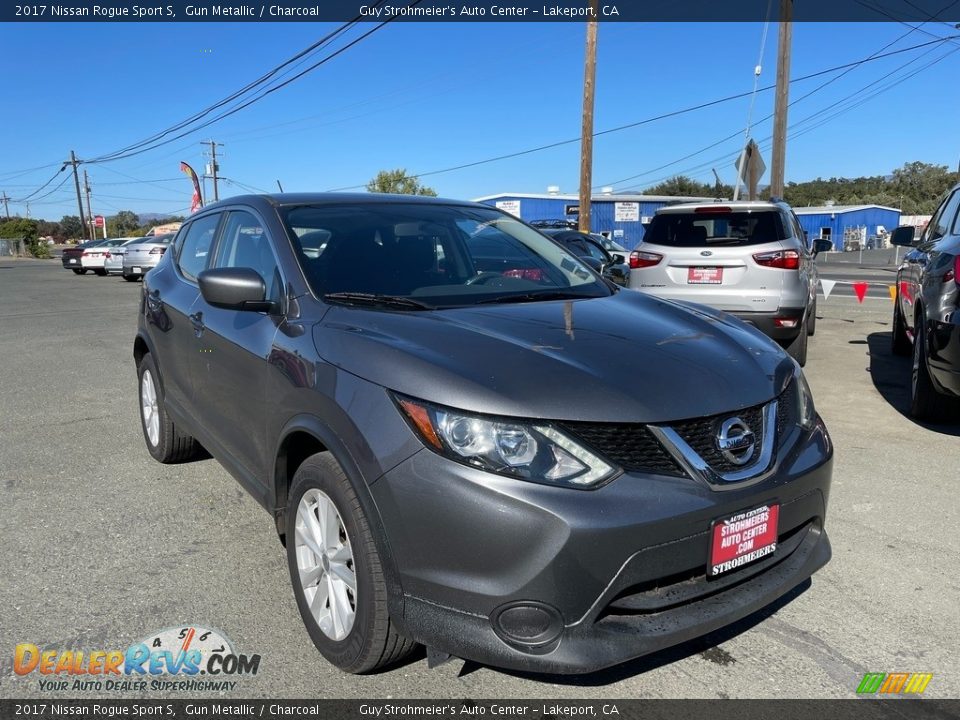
[477,193,713,250]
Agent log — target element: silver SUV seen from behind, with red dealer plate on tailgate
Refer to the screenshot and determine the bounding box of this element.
[629,201,818,365]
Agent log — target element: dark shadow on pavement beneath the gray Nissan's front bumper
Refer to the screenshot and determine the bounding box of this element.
[468,578,813,687]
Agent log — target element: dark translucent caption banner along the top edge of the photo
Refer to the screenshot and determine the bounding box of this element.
[0,0,960,22]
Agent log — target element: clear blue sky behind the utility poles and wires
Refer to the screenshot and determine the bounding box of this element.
[0,22,960,219]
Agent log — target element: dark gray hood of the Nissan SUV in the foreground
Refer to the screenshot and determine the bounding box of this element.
[314,291,794,422]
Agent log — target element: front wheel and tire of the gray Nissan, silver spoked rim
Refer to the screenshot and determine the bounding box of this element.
[286,453,416,673]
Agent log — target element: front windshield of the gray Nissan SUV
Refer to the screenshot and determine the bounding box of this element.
[281,203,610,307]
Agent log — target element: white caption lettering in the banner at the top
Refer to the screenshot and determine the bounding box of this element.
[14,4,620,20]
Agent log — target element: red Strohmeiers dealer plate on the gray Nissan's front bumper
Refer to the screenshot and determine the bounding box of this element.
[707,503,780,577]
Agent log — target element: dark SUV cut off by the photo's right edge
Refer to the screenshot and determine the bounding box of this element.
[891,185,960,421]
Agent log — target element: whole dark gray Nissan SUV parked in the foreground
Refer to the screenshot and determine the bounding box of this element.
[133,194,833,673]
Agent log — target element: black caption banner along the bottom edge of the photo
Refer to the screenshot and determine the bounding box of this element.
[0,698,960,720]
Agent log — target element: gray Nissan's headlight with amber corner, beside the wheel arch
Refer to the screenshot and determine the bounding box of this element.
[396,397,618,490]
